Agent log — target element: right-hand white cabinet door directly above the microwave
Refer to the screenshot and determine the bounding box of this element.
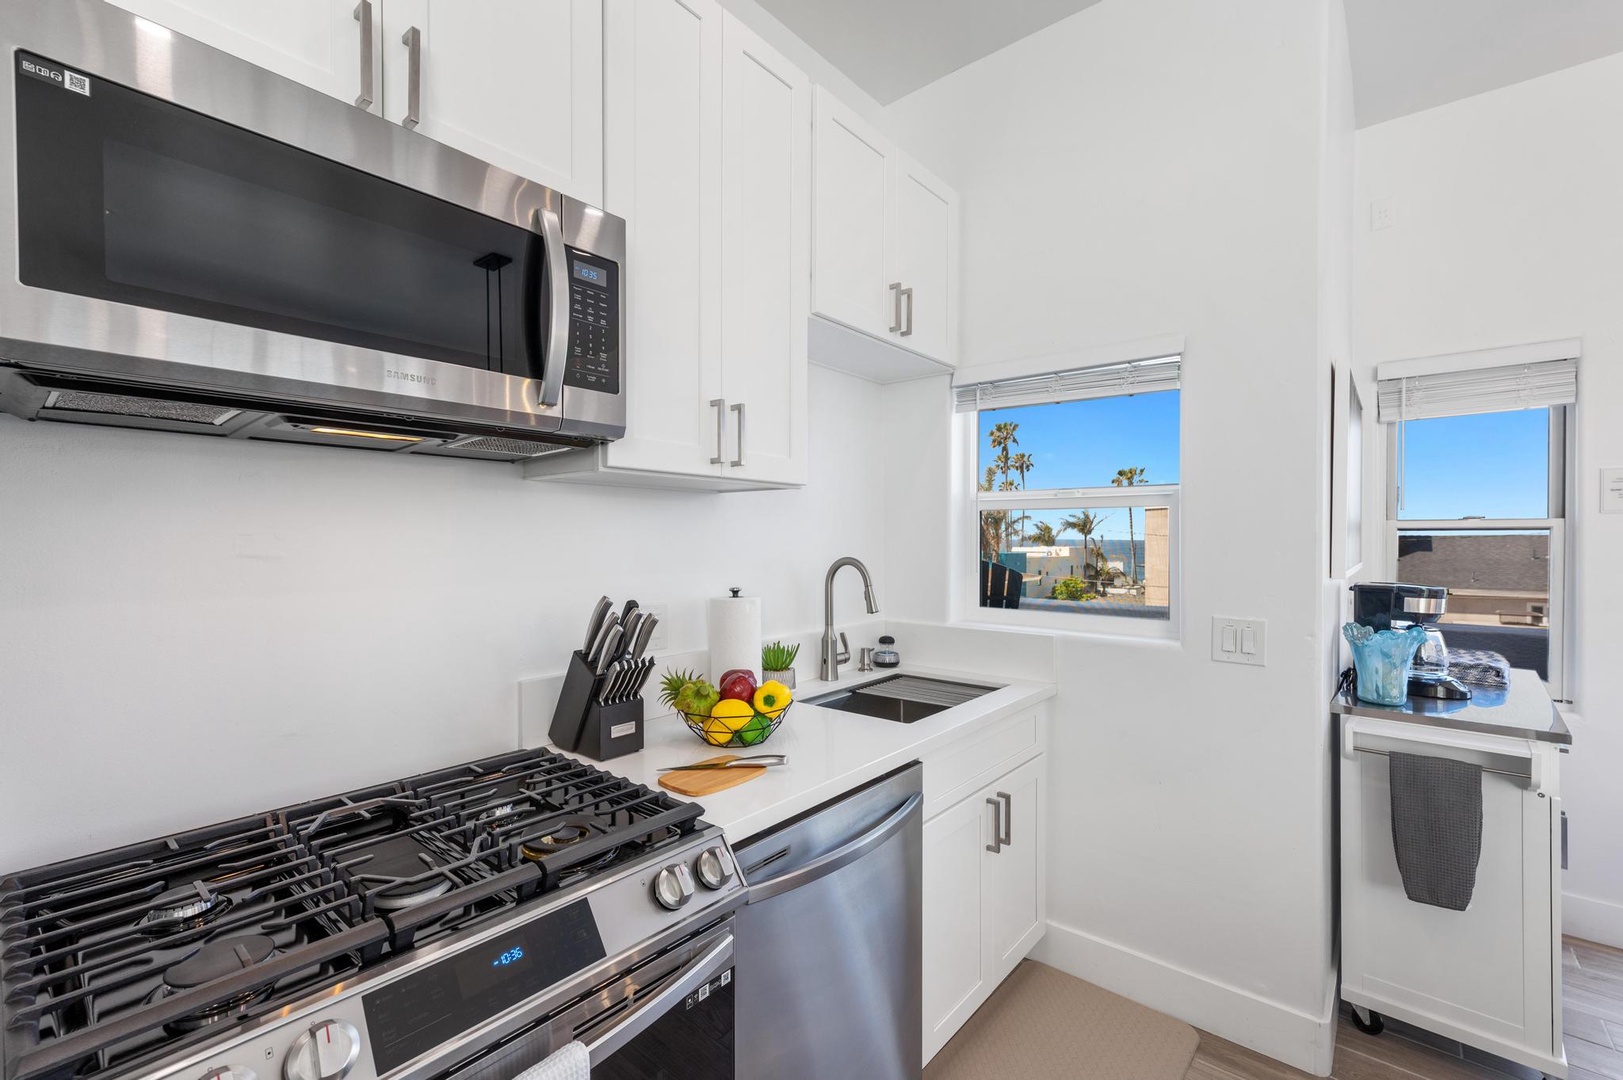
[387,0,604,206]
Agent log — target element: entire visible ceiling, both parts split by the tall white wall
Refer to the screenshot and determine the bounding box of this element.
[760,0,1623,127]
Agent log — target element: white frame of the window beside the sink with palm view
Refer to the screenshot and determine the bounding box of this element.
[949,406,1183,642]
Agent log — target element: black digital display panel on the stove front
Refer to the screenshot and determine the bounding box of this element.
[362,900,607,1075]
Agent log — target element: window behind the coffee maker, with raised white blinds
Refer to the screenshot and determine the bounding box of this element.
[1380,348,1578,697]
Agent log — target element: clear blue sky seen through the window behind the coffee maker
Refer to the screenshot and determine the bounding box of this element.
[1395,409,1550,521]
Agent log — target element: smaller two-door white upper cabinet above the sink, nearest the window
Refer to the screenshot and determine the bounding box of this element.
[812,88,959,382]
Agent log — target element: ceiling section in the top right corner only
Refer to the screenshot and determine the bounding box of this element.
[1345,0,1623,127]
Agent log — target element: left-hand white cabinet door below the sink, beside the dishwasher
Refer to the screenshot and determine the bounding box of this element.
[923,789,992,1061]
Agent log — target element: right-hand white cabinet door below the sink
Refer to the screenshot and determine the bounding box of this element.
[980,757,1045,979]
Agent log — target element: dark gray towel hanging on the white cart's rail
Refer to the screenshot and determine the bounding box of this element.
[1388,754,1482,911]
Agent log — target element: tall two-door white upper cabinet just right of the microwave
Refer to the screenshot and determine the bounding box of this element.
[524,0,812,490]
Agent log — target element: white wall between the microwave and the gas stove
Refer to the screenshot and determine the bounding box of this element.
[0,369,885,870]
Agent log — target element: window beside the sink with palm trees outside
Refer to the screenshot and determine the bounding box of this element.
[956,357,1180,624]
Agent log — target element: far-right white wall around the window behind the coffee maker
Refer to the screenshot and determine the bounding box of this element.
[1354,55,1623,945]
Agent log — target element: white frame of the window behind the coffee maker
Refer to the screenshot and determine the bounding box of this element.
[1384,404,1576,702]
